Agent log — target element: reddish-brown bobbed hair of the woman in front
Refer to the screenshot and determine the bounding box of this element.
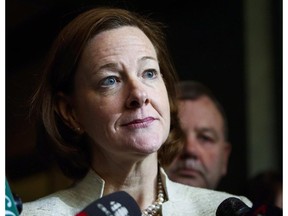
[30,7,181,179]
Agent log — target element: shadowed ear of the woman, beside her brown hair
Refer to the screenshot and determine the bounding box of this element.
[55,92,81,132]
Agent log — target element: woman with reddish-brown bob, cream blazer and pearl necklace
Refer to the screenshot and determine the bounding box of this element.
[21,8,250,216]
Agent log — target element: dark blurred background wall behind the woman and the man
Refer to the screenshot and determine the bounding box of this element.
[5,0,283,201]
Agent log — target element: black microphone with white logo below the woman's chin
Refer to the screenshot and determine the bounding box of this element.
[75,191,141,216]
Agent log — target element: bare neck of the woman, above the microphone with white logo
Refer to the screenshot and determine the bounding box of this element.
[93,155,160,209]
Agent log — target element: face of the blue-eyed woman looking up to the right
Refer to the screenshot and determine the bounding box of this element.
[69,27,170,160]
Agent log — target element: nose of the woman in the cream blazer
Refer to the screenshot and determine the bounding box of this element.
[126,81,149,108]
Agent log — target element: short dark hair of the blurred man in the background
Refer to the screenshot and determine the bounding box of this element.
[177,80,228,141]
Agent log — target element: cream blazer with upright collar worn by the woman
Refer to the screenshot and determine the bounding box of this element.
[21,168,252,216]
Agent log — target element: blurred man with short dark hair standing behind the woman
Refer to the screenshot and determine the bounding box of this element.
[167,81,231,189]
